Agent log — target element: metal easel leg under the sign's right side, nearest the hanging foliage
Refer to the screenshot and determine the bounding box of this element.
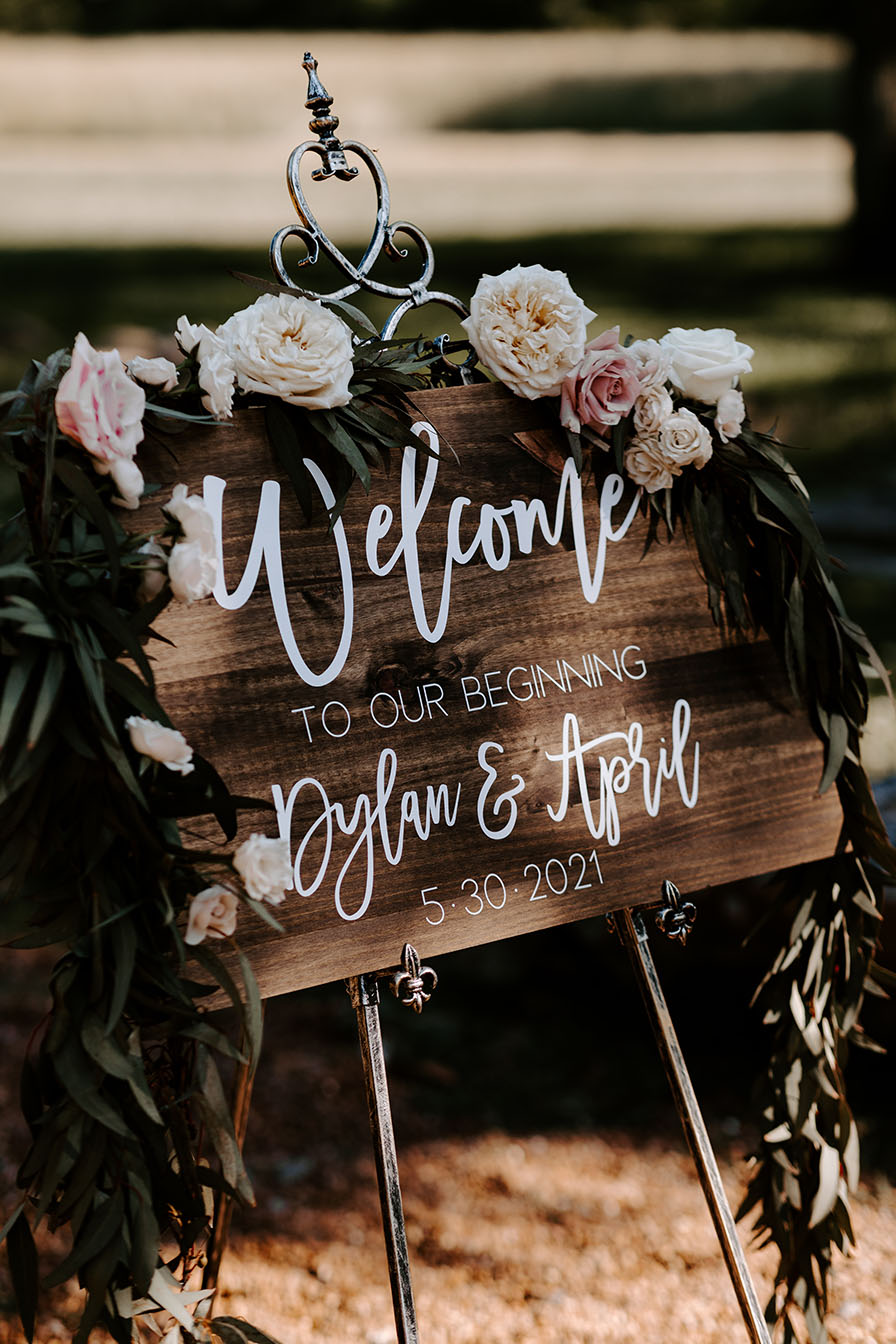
[614,910,771,1344]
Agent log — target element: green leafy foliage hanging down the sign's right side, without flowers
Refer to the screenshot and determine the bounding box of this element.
[571,399,896,1344]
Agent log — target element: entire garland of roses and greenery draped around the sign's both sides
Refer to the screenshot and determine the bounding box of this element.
[0,266,896,1344]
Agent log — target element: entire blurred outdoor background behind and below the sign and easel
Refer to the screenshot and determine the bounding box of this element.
[0,0,896,1344]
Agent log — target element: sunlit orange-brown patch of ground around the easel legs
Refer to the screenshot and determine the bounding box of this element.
[7,1132,896,1344]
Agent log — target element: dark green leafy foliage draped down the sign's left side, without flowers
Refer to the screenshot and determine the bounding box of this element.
[0,314,443,1344]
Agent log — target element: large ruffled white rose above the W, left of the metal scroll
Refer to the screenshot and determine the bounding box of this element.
[216,294,353,410]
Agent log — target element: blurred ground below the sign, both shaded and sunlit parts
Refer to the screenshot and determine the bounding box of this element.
[0,930,896,1344]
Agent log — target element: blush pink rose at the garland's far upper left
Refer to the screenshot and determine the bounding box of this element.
[55,332,146,476]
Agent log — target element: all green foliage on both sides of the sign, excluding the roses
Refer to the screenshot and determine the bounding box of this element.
[0,307,896,1344]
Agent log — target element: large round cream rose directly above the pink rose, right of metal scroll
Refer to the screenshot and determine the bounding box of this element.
[461,266,596,399]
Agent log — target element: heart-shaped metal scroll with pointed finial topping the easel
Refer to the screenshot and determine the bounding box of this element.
[270,54,469,339]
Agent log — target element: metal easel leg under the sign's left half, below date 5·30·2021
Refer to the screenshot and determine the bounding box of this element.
[348,974,419,1344]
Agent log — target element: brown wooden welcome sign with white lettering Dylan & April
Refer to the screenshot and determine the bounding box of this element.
[140,384,841,995]
